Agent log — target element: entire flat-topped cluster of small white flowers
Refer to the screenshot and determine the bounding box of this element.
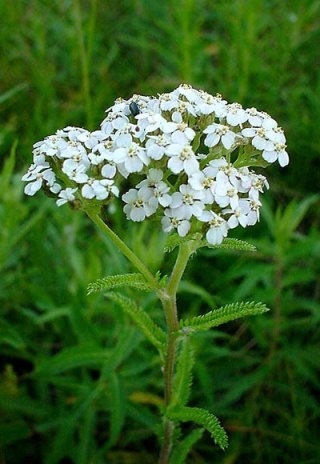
[22,85,289,244]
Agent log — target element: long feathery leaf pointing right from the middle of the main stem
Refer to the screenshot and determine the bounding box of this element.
[180,301,269,331]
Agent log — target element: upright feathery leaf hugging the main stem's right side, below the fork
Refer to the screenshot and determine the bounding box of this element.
[170,337,194,407]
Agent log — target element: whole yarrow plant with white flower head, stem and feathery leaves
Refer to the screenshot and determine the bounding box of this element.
[22,85,289,464]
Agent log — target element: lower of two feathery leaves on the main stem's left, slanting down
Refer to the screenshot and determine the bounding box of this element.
[106,292,167,358]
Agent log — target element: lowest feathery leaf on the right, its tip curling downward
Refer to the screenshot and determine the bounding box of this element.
[166,406,228,450]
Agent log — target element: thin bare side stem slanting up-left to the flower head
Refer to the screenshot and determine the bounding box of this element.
[86,211,161,292]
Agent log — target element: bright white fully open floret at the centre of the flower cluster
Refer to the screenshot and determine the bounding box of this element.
[166,143,199,175]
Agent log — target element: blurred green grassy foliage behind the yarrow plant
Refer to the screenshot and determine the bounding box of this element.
[0,0,320,464]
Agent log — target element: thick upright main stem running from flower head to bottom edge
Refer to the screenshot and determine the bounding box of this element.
[158,242,196,464]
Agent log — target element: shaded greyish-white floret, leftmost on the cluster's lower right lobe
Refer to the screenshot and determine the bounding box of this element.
[122,189,156,222]
